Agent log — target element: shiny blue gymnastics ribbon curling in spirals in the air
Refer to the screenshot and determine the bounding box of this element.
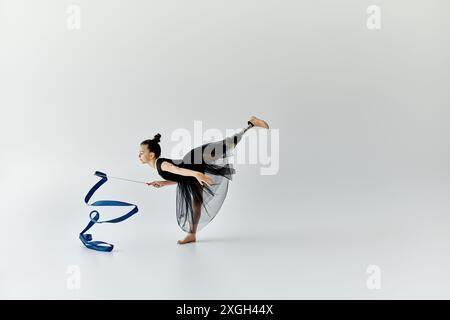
[80,171,139,252]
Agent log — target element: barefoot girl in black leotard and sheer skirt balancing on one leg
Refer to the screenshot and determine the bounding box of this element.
[139,116,269,244]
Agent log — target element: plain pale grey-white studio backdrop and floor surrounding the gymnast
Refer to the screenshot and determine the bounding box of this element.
[0,0,450,299]
